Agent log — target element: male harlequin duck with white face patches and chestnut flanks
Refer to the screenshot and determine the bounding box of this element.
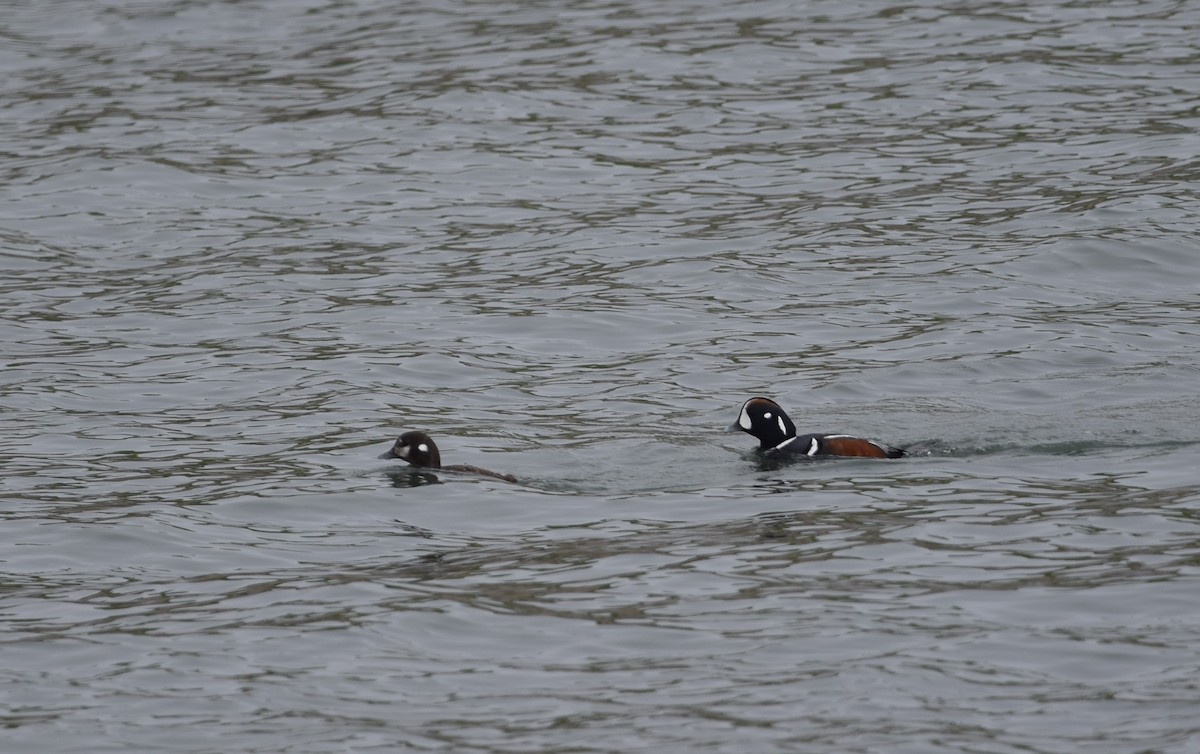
[730,397,905,459]
